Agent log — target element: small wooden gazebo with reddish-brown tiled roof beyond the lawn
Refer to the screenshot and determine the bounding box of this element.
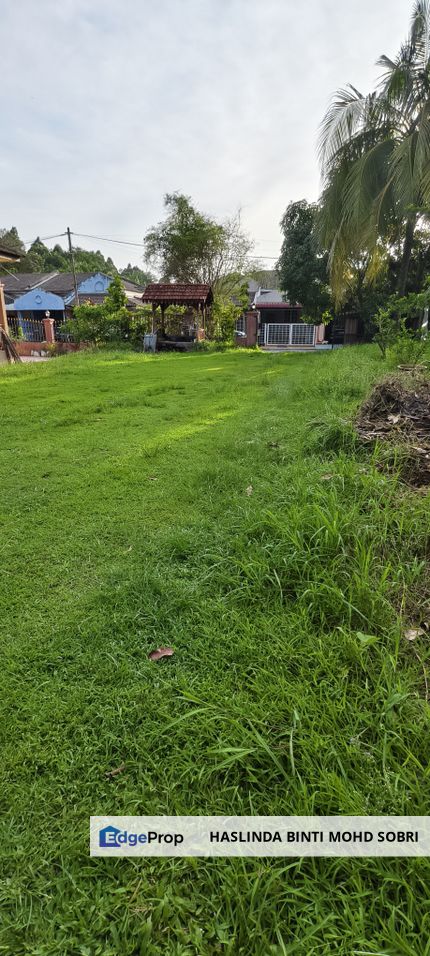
[142,282,213,339]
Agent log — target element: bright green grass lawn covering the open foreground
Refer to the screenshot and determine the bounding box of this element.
[0,347,430,956]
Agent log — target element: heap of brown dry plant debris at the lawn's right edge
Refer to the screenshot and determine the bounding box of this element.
[356,376,430,486]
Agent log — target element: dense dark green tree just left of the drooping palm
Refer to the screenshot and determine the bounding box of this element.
[277,199,331,318]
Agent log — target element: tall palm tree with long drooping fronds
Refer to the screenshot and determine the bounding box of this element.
[320,0,430,300]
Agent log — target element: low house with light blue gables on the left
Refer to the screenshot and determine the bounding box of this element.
[1,272,143,338]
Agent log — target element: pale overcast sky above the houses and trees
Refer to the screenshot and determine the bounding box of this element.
[0,0,411,266]
